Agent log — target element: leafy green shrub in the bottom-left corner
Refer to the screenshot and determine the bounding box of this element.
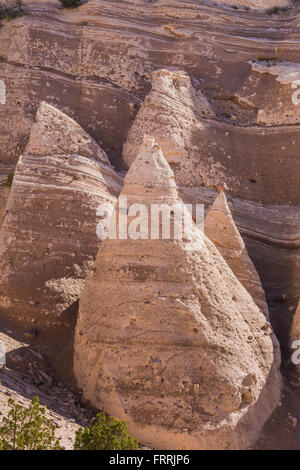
[0,397,61,450]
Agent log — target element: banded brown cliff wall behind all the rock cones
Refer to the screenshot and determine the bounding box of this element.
[0,0,300,449]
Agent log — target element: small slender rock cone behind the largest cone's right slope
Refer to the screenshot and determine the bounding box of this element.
[204,191,269,318]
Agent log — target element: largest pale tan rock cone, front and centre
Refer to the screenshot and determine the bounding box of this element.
[74,137,280,449]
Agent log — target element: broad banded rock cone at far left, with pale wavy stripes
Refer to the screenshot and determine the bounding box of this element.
[0,103,122,326]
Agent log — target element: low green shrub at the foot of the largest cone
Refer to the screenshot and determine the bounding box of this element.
[74,413,138,450]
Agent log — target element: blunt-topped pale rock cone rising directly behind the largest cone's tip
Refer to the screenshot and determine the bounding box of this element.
[123,69,214,185]
